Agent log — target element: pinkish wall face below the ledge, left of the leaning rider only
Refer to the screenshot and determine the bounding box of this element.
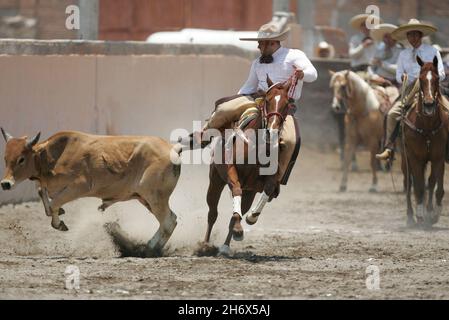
[0,55,250,203]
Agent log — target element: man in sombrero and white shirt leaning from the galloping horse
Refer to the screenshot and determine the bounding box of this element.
[184,23,318,184]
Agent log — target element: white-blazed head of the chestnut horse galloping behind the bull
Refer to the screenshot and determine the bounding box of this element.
[264,75,291,132]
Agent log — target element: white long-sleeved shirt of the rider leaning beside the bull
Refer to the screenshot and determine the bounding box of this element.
[238,47,318,100]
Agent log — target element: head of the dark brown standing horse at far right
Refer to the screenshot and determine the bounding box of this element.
[416,56,440,117]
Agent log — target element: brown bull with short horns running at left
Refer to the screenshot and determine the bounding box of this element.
[1,128,180,252]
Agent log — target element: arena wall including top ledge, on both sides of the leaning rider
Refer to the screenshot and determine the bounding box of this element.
[0,40,347,203]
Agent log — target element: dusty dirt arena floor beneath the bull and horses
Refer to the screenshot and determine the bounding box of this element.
[0,148,449,299]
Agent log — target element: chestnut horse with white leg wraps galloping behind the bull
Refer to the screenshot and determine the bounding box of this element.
[198,76,291,255]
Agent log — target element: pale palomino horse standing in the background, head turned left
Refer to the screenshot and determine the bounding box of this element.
[330,70,383,192]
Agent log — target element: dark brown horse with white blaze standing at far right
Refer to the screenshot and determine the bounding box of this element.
[402,57,448,227]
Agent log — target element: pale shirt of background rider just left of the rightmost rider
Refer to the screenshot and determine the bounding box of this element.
[372,41,404,80]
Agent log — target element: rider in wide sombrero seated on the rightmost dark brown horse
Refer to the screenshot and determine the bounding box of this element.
[376,19,447,160]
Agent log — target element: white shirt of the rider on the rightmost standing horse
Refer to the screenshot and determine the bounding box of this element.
[396,43,446,84]
